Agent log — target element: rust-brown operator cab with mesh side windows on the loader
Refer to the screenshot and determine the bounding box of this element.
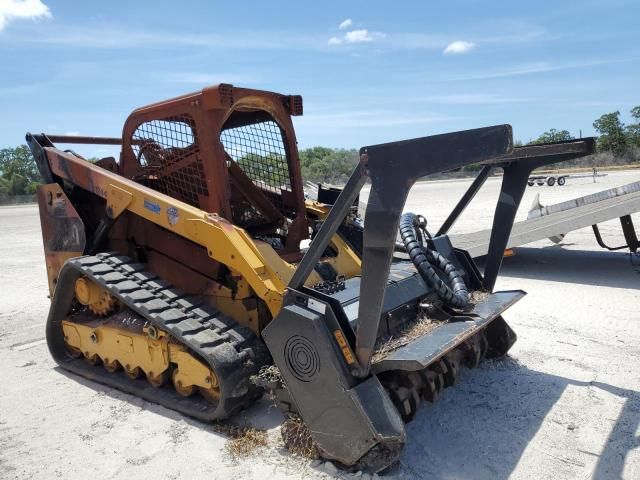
[120,84,309,261]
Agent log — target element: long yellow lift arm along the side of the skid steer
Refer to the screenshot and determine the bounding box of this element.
[45,147,360,316]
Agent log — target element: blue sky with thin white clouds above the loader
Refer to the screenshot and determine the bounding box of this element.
[0,0,640,155]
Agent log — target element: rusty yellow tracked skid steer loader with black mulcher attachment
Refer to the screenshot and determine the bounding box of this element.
[26,84,527,472]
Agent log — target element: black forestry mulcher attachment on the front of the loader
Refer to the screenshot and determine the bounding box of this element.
[263,126,524,472]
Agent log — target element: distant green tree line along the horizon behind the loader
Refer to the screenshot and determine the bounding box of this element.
[0,105,640,199]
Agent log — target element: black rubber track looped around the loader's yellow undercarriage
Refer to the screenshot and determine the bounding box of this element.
[47,253,271,421]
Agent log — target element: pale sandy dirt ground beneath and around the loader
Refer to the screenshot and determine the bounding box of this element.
[0,172,640,480]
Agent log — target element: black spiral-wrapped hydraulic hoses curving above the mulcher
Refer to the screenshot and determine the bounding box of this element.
[400,213,470,308]
